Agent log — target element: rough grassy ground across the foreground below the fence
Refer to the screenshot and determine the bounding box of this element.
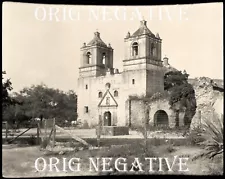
[2,138,223,177]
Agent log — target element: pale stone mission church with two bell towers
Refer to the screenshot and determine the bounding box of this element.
[78,20,181,127]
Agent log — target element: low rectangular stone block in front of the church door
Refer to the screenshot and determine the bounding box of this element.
[96,126,129,136]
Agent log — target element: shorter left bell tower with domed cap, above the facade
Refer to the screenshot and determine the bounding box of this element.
[79,32,113,77]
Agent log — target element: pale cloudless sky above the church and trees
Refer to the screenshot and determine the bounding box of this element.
[2,2,223,92]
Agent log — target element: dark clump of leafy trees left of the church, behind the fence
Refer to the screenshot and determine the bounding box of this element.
[3,84,77,125]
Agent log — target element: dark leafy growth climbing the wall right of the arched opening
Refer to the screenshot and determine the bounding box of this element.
[164,71,197,127]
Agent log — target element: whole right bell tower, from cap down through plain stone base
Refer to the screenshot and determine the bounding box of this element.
[123,20,164,96]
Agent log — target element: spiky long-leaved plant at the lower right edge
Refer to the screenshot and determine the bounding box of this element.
[194,115,224,159]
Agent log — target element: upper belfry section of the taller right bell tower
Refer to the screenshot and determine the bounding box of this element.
[123,20,162,70]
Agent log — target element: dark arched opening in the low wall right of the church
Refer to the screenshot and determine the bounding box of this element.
[154,110,169,126]
